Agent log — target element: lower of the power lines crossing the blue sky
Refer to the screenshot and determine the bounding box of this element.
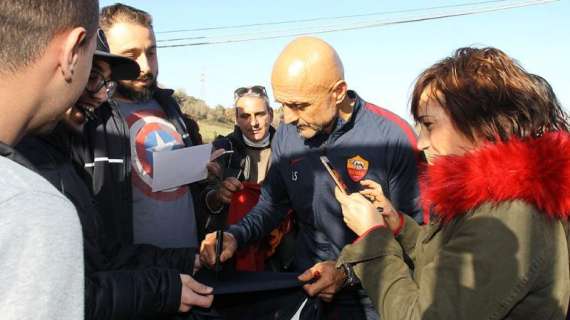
[158,0,558,48]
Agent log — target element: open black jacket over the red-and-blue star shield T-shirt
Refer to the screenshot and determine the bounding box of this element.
[75,89,205,244]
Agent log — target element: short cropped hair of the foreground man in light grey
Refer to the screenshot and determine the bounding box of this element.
[0,0,99,72]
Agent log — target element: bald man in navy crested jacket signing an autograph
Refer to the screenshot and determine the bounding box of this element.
[201,37,420,319]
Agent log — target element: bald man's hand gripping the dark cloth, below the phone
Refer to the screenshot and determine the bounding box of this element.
[299,261,346,302]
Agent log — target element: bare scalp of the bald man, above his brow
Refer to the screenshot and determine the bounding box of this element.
[271,37,344,95]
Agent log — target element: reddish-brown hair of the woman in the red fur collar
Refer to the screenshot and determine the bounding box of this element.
[411,48,568,141]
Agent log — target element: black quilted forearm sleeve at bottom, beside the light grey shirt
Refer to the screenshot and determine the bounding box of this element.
[85,268,182,320]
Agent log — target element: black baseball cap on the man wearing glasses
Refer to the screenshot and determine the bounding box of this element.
[93,29,140,80]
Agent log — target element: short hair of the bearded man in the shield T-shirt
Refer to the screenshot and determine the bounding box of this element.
[99,3,152,32]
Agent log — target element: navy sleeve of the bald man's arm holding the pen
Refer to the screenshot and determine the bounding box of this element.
[228,128,291,247]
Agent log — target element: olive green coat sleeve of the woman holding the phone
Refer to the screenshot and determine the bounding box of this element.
[338,203,549,320]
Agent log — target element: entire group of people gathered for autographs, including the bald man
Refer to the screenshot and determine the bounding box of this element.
[0,0,570,320]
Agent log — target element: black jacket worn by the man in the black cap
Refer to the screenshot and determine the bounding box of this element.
[17,126,196,319]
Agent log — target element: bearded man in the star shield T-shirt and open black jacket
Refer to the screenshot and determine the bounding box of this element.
[77,3,205,252]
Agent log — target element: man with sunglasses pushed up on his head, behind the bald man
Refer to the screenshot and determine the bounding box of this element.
[206,85,294,271]
